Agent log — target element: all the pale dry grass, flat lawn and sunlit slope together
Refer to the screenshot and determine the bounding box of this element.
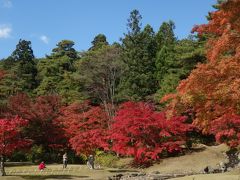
[0,145,240,180]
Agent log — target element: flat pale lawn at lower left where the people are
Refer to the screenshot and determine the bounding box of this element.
[0,164,136,180]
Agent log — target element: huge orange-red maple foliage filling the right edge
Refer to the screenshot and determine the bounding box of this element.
[161,0,240,146]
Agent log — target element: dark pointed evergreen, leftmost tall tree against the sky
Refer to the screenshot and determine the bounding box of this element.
[0,39,37,96]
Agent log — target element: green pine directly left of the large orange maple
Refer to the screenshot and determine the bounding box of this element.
[156,37,205,101]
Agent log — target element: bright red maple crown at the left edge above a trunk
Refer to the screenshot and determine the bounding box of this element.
[0,117,31,156]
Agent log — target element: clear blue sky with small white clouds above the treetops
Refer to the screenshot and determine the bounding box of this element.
[0,0,216,59]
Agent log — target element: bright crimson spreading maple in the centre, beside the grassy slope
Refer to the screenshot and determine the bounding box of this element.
[111,102,191,163]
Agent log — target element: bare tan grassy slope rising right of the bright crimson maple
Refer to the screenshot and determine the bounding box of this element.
[145,144,228,174]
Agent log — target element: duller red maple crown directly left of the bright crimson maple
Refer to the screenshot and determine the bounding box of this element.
[58,101,109,154]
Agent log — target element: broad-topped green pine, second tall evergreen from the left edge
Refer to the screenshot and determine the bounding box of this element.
[35,40,81,103]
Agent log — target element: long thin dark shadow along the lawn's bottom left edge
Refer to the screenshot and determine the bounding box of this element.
[20,175,89,180]
